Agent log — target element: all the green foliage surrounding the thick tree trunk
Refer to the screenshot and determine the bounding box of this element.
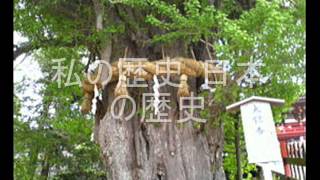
[14,0,305,179]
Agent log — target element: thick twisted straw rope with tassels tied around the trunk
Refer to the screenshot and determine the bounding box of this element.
[81,57,222,114]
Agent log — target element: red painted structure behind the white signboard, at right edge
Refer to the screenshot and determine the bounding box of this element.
[277,97,306,177]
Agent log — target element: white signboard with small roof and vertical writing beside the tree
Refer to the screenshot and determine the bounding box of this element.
[227,96,284,180]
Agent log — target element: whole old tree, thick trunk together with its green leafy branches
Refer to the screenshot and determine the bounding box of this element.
[14,0,305,180]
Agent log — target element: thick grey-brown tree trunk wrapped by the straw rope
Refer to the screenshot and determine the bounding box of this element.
[90,0,225,180]
